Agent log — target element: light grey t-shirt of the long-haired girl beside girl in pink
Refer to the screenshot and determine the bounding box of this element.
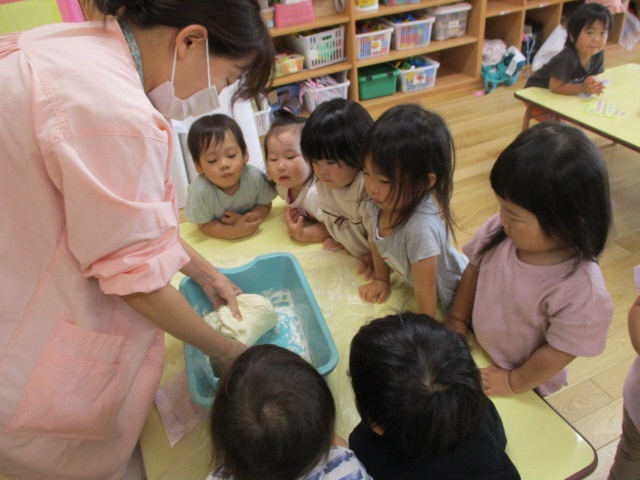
[369,197,469,310]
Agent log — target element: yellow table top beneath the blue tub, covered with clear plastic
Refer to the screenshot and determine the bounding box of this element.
[140,199,596,480]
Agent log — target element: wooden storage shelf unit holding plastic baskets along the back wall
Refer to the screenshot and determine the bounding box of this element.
[271,0,624,108]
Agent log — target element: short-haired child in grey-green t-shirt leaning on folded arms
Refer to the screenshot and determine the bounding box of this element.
[185,114,276,239]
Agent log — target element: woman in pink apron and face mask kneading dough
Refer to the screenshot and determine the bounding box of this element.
[0,0,274,480]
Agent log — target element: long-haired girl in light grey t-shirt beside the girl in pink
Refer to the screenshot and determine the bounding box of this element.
[360,104,467,317]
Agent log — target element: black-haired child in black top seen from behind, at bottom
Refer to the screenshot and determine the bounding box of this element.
[349,312,520,480]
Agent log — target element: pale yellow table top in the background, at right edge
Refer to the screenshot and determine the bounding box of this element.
[514,63,640,151]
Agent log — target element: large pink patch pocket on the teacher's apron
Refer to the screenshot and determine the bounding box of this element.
[9,320,126,440]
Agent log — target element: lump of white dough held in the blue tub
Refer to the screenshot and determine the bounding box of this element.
[204,293,278,346]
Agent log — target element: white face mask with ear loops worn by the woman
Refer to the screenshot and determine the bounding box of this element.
[147,40,220,120]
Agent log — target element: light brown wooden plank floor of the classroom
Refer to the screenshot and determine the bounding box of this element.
[372,45,640,479]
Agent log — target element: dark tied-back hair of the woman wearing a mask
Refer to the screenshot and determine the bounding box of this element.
[93,0,275,100]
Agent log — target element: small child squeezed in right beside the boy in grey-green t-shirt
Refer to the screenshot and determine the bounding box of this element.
[264,109,329,241]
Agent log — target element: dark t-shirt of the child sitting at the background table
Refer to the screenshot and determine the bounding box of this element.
[525,46,604,88]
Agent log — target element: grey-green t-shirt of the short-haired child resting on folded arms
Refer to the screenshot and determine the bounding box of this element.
[185,164,277,224]
